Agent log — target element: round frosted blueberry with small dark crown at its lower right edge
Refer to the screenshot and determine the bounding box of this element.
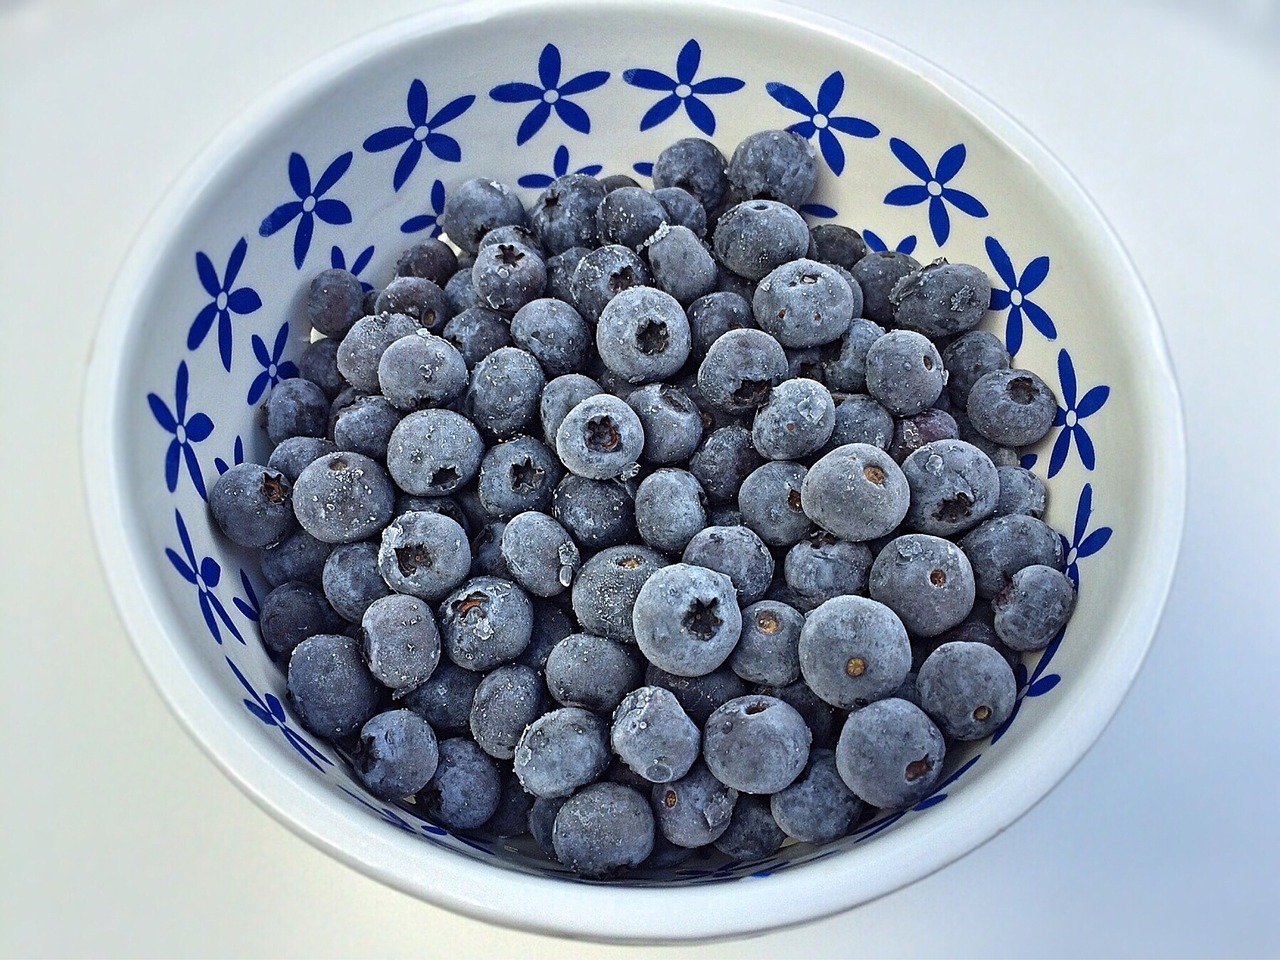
[387,410,485,497]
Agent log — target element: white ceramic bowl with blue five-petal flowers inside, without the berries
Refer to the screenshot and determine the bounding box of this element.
[84,0,1184,941]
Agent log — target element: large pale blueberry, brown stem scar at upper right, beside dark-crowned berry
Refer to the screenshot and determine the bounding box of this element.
[800,443,910,540]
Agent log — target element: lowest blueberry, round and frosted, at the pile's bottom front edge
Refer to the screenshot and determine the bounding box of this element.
[552,783,654,877]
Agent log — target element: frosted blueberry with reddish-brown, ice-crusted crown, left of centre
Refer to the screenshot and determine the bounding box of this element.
[439,577,534,671]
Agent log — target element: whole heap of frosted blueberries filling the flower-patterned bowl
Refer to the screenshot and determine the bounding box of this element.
[210,131,1075,877]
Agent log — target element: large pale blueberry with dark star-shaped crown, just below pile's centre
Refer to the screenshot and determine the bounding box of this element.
[631,563,742,677]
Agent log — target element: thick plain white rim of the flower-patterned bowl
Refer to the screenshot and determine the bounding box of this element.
[81,0,1187,942]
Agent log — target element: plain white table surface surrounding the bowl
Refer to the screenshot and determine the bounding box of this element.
[0,0,1280,960]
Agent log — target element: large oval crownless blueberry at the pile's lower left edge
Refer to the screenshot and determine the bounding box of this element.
[288,634,378,739]
